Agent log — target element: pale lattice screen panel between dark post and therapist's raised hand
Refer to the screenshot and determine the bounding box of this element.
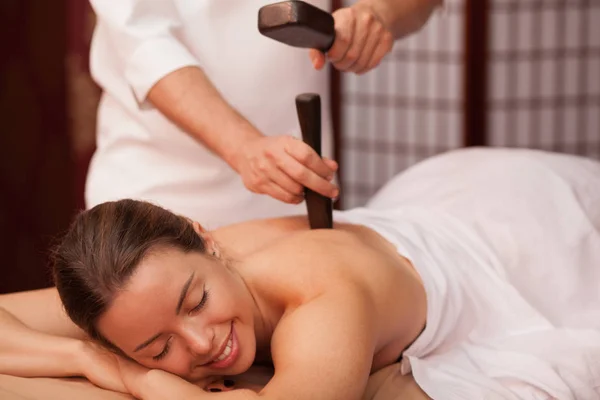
[340,0,464,208]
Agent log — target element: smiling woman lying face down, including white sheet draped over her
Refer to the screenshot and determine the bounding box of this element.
[0,149,600,400]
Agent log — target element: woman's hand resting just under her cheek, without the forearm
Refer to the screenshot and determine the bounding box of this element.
[79,341,129,393]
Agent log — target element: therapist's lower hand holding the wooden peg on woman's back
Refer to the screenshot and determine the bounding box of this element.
[234,136,339,204]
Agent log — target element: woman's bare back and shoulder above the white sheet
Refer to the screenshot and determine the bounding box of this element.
[241,224,426,372]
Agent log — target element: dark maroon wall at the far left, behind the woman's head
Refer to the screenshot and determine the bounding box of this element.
[0,0,86,293]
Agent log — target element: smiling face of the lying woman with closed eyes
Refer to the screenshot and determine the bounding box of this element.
[98,249,256,380]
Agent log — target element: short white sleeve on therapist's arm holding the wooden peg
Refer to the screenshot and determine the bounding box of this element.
[90,0,200,104]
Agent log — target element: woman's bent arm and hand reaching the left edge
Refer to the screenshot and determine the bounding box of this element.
[0,288,126,392]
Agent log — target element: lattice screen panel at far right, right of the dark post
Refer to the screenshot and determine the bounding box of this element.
[488,0,600,158]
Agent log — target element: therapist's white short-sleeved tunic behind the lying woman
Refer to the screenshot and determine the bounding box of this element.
[85,0,332,229]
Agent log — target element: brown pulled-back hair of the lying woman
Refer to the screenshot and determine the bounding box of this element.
[52,200,206,347]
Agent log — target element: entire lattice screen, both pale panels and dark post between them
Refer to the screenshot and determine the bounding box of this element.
[339,0,600,208]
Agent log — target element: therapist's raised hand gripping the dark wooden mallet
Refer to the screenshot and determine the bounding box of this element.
[309,2,394,74]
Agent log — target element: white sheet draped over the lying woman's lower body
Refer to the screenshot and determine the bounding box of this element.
[335,149,600,400]
